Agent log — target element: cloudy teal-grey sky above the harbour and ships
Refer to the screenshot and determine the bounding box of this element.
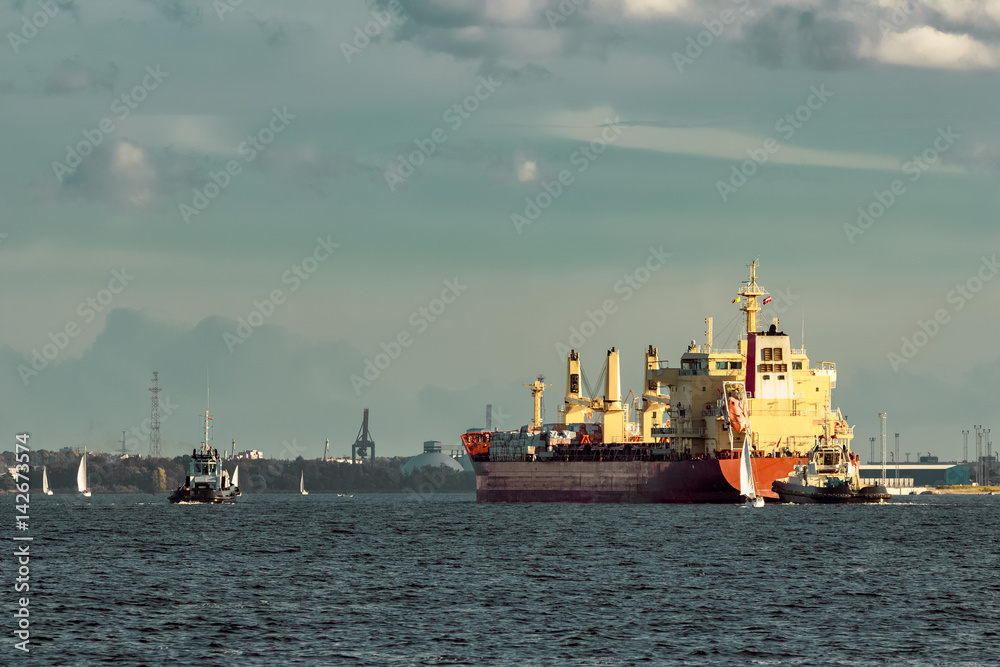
[0,0,1000,460]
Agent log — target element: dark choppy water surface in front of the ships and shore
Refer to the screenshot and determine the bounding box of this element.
[7,494,1000,666]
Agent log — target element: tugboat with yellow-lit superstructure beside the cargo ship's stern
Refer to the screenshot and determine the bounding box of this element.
[771,424,891,503]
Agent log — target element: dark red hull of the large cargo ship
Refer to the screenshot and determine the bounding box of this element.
[473,457,805,503]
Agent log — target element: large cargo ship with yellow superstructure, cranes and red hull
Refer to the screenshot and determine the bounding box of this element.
[462,261,853,503]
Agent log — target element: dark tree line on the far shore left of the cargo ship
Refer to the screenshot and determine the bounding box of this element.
[0,450,476,495]
